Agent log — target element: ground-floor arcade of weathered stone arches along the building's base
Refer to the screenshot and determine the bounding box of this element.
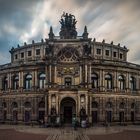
[0,94,137,125]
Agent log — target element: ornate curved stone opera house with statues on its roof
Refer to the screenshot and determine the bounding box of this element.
[0,13,140,125]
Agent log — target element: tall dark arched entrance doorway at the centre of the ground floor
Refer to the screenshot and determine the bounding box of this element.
[60,97,76,123]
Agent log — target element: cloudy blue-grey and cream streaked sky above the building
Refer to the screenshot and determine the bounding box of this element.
[0,0,140,64]
